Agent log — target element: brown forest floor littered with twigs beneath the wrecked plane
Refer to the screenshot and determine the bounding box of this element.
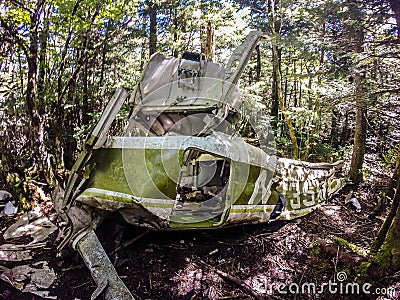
[0,177,400,300]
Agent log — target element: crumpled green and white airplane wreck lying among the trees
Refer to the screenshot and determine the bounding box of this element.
[52,31,344,299]
